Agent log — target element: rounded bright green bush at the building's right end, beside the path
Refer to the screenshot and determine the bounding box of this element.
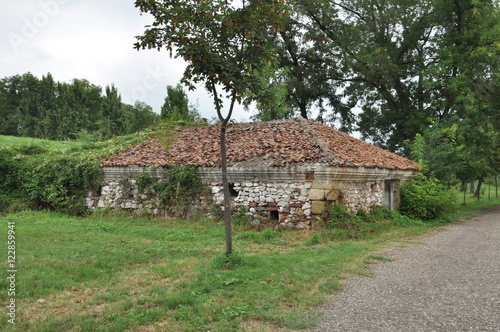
[400,174,455,220]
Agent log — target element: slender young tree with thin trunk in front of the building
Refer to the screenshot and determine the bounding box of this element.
[135,0,286,255]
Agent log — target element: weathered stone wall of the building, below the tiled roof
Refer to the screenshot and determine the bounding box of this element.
[87,165,413,229]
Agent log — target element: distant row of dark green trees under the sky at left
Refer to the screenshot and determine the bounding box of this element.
[0,73,160,140]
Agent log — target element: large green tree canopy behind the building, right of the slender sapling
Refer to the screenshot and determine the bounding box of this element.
[266,0,500,152]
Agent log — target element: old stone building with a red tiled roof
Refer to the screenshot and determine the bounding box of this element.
[87,118,417,228]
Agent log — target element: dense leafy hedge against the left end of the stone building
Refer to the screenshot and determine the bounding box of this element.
[0,146,102,214]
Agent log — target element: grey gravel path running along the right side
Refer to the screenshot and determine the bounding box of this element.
[310,208,500,332]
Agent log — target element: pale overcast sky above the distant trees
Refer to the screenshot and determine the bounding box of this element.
[0,0,251,122]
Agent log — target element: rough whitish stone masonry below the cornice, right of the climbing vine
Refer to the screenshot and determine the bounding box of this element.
[210,181,384,228]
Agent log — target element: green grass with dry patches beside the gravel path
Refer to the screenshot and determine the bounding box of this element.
[0,191,500,332]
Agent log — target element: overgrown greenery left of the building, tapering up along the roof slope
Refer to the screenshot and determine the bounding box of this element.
[0,132,156,214]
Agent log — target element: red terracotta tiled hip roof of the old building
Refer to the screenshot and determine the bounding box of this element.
[102,119,417,170]
